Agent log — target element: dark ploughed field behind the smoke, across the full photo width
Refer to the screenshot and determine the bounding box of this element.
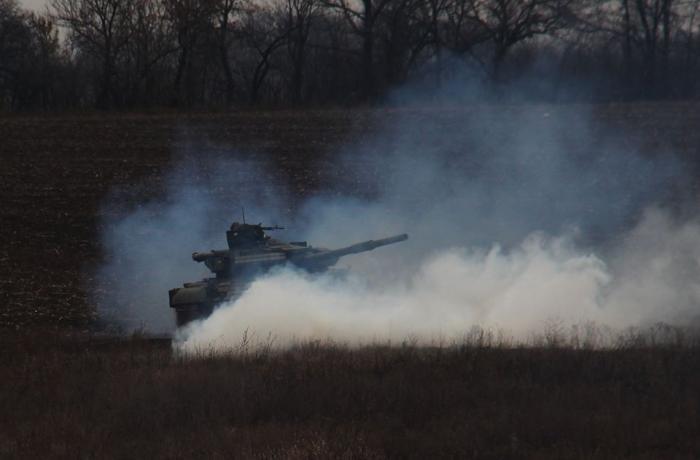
[0,103,700,330]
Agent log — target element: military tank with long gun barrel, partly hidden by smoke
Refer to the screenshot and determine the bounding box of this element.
[169,222,408,327]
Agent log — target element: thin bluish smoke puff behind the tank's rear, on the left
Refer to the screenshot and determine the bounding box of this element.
[93,154,288,333]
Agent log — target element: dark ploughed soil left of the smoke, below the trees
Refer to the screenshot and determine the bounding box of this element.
[0,112,362,329]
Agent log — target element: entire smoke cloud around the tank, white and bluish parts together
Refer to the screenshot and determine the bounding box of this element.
[95,76,700,350]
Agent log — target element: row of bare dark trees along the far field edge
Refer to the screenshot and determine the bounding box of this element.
[0,0,700,110]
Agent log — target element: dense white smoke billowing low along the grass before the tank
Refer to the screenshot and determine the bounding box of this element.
[179,209,700,351]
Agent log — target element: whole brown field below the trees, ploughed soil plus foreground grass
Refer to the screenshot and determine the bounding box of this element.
[0,103,700,458]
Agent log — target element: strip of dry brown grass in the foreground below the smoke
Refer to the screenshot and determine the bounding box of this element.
[0,332,700,458]
